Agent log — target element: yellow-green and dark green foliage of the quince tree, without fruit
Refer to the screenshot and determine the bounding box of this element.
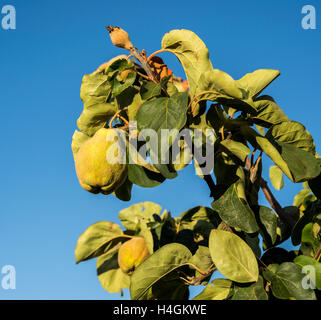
[72,27,321,300]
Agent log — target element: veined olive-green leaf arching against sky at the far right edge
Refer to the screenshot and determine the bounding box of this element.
[266,121,315,155]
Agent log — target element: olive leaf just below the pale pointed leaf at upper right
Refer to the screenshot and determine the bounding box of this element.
[252,96,289,127]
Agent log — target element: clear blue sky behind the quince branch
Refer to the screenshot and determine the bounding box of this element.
[0,0,321,299]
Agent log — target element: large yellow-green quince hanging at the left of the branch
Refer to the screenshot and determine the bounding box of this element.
[75,128,127,194]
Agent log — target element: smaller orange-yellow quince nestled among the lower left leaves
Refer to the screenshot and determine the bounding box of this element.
[118,237,150,274]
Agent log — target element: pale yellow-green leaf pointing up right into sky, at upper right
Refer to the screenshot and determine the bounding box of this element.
[236,69,280,98]
